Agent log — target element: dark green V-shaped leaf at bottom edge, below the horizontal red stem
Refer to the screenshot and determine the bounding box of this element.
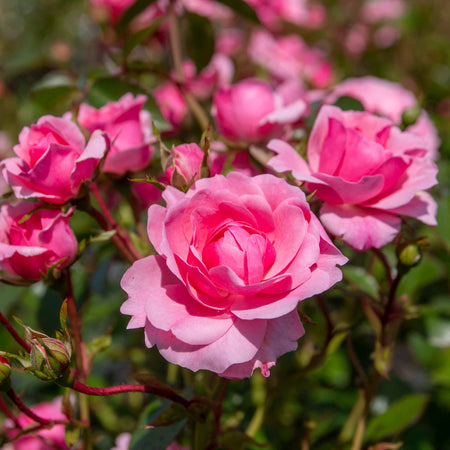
[130,400,187,450]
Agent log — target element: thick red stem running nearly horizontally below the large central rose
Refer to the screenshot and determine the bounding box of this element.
[71,380,189,408]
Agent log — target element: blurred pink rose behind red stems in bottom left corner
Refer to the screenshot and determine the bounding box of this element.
[4,397,69,450]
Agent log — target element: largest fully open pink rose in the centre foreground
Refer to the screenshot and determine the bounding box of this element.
[121,172,346,378]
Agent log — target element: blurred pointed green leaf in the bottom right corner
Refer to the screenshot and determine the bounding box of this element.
[365,394,428,441]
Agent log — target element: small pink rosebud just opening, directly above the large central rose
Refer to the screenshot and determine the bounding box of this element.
[166,144,204,187]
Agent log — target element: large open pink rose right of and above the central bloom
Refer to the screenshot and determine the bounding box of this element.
[268,106,437,250]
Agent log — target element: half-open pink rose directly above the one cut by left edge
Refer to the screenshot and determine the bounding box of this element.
[2,116,109,205]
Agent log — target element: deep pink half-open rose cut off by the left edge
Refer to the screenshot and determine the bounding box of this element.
[0,202,78,280]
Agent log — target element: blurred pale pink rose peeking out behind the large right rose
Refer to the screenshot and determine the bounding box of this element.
[325,76,440,159]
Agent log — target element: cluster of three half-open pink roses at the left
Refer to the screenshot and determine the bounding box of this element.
[0,94,154,281]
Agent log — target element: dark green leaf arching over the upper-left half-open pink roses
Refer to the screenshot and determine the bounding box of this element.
[88,77,170,131]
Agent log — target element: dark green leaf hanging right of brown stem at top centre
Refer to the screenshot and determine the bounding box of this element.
[185,13,215,72]
